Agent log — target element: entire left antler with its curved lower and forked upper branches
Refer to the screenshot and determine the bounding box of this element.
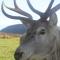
[1,0,34,24]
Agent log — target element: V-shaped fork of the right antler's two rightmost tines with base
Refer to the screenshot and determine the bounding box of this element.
[40,0,60,20]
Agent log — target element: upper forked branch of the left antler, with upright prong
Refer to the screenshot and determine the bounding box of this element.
[5,0,32,19]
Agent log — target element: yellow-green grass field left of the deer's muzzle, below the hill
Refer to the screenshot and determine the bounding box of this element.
[0,37,20,60]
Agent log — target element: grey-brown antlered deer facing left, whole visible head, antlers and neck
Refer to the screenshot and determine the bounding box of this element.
[1,0,60,60]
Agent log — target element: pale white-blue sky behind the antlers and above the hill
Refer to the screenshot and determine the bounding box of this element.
[0,0,60,30]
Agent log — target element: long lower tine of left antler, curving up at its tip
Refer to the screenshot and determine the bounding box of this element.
[1,2,33,23]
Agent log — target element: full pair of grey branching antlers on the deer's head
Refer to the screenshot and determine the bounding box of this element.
[1,0,60,23]
